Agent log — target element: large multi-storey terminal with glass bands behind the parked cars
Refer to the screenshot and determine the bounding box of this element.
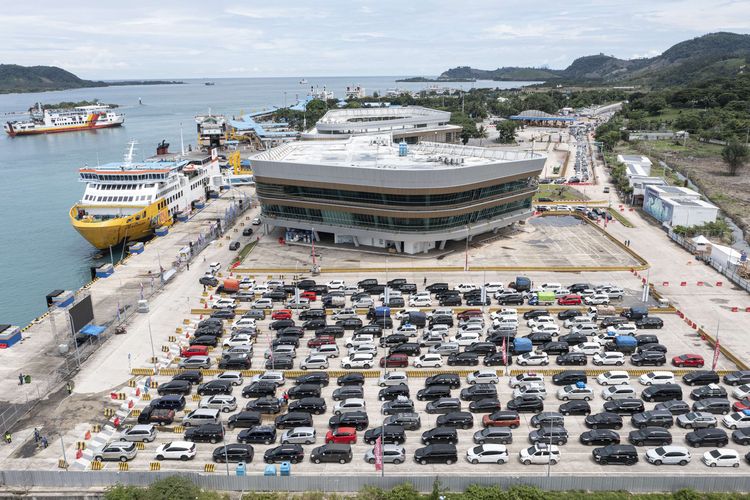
[253,135,545,254]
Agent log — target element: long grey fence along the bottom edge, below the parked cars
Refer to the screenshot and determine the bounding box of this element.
[0,470,750,493]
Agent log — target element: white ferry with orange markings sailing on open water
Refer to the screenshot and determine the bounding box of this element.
[3,105,125,137]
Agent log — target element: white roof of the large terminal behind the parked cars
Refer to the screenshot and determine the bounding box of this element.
[255,135,544,170]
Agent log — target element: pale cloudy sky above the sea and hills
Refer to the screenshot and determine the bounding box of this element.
[0,0,750,79]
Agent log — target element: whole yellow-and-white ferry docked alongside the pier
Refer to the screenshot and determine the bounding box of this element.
[70,141,222,250]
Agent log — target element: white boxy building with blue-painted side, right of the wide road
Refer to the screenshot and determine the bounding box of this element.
[643,185,719,227]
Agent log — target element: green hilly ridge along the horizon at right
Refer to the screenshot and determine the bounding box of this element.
[441,32,750,87]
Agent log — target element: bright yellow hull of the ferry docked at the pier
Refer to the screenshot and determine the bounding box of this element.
[69,201,172,250]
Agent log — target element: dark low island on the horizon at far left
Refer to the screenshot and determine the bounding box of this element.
[0,64,184,94]
